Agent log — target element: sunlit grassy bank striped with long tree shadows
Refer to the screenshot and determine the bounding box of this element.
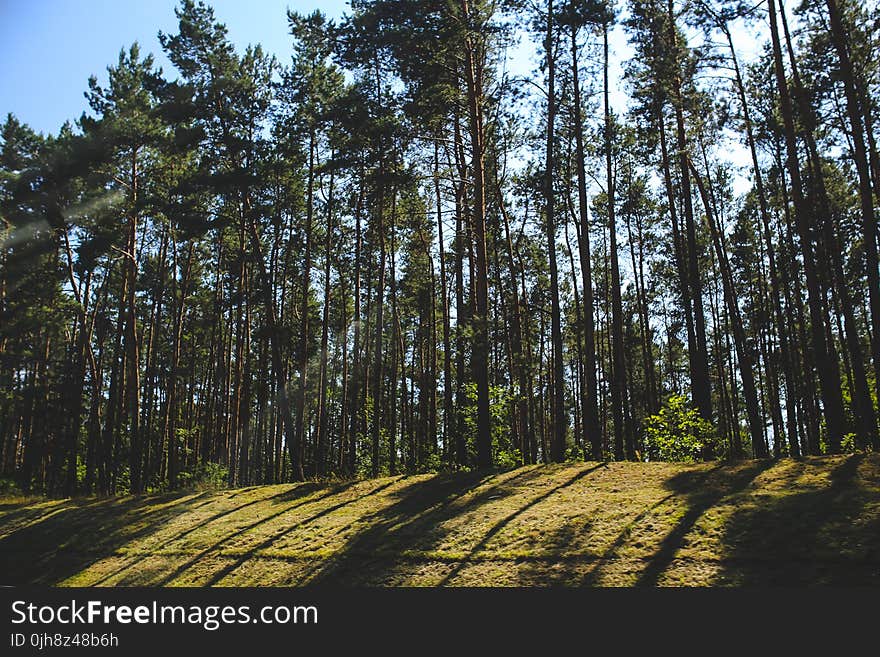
[0,454,880,586]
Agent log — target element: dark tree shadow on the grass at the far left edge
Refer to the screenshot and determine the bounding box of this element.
[0,493,204,586]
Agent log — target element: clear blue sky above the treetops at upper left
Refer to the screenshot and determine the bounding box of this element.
[0,0,348,133]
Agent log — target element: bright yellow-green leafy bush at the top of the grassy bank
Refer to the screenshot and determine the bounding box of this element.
[644,395,717,463]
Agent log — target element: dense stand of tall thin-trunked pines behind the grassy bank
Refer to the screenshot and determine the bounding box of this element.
[0,0,880,497]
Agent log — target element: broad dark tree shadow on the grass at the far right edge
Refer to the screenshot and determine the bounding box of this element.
[713,454,880,586]
